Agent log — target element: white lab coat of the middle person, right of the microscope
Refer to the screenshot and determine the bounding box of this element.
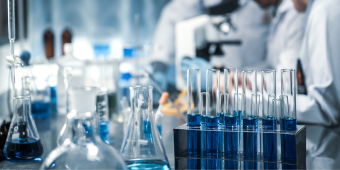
[247,0,305,71]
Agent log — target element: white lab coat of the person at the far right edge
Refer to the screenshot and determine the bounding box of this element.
[296,0,340,126]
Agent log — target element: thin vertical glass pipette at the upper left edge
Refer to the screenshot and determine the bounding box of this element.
[6,0,24,93]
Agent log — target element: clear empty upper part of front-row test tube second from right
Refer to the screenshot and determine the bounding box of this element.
[261,69,276,121]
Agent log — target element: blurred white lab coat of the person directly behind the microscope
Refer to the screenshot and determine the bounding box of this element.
[152,0,268,67]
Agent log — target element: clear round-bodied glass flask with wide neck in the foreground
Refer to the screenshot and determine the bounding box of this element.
[40,111,127,170]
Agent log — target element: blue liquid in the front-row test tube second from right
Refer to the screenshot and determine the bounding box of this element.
[262,116,277,170]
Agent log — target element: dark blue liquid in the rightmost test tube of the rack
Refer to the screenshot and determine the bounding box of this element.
[281,117,297,167]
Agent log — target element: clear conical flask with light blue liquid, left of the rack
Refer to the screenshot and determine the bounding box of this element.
[121,86,170,170]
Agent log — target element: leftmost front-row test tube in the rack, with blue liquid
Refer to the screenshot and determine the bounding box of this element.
[187,69,201,169]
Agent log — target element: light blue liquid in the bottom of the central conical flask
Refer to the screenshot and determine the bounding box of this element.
[125,160,170,170]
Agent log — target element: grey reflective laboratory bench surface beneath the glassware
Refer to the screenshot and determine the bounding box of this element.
[0,115,340,169]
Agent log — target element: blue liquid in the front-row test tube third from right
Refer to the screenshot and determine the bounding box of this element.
[243,116,258,169]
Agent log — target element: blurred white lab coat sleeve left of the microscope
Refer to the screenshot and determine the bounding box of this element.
[151,0,202,63]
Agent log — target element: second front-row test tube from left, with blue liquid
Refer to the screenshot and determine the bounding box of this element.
[206,69,223,169]
